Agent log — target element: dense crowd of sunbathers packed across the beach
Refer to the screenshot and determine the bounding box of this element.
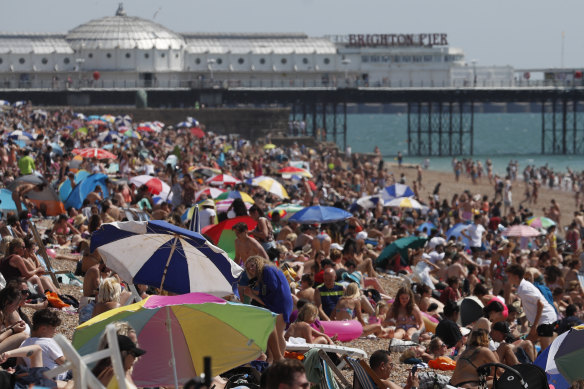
[0,104,584,389]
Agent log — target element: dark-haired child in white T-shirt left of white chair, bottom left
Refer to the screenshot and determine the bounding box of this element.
[20,308,67,381]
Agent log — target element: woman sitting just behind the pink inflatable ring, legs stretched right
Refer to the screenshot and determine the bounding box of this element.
[331,282,393,338]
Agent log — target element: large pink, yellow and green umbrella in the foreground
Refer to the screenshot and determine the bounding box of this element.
[73,293,276,387]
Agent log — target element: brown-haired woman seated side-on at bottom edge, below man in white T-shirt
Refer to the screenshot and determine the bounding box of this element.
[450,329,499,388]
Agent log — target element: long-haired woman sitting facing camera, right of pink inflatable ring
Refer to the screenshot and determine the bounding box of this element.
[385,286,424,340]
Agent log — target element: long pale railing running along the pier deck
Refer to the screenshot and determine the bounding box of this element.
[0,76,584,90]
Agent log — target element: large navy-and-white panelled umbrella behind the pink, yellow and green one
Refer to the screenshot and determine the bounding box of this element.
[91,220,243,297]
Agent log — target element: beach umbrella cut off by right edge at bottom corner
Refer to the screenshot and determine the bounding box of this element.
[546,325,584,382]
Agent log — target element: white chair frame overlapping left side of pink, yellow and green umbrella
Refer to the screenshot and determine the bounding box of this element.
[45,324,127,389]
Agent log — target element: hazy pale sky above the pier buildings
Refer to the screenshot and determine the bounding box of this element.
[0,0,584,68]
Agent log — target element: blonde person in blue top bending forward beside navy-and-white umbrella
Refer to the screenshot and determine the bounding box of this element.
[243,255,294,361]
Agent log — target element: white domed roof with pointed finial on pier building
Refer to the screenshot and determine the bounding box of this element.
[66,5,185,50]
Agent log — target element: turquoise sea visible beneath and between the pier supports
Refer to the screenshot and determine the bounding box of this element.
[338,113,584,174]
